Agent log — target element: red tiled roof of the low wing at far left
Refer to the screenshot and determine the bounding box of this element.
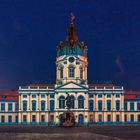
[0,91,18,101]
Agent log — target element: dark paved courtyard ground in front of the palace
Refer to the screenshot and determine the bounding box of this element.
[0,125,140,140]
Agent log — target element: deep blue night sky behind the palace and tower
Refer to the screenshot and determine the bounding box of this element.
[0,0,140,90]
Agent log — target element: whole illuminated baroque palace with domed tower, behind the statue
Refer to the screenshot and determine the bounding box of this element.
[0,16,140,125]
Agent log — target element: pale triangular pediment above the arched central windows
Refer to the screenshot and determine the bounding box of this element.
[57,82,87,89]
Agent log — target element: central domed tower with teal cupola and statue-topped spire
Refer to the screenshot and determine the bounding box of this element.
[56,14,88,85]
